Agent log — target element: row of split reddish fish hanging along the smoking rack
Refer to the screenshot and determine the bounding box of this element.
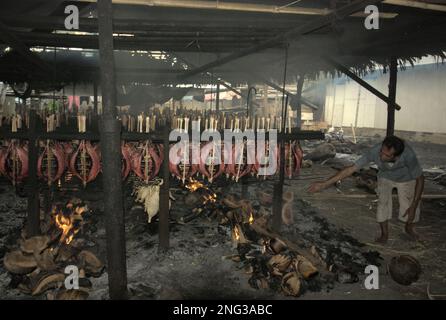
[0,140,303,186]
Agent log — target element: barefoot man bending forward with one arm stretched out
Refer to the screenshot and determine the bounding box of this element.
[308,136,424,243]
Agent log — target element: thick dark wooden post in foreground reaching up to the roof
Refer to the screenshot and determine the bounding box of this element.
[98,0,127,299]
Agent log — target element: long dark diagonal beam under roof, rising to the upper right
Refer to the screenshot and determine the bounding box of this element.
[179,0,383,80]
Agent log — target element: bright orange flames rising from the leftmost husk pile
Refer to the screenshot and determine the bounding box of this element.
[54,203,86,244]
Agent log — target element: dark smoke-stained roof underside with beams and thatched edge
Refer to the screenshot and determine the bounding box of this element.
[0,0,446,91]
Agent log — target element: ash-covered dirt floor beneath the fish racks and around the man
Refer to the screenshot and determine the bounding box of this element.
[0,139,446,299]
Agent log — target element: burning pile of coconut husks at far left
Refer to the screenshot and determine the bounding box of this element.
[3,202,104,300]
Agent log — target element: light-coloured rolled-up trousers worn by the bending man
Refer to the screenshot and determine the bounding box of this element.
[376,178,420,222]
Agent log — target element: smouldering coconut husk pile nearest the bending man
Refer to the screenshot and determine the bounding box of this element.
[211,195,330,297]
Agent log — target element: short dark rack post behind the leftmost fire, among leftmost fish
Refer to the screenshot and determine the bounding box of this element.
[26,109,41,237]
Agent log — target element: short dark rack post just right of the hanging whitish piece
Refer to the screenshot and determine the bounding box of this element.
[158,122,170,251]
